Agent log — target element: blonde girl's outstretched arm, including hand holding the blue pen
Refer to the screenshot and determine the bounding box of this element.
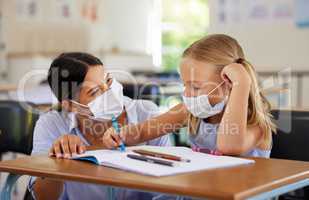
[102,104,188,148]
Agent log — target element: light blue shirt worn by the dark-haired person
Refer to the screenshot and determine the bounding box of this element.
[29,97,171,200]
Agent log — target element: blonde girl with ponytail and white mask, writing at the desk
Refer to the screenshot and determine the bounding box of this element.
[97,34,275,157]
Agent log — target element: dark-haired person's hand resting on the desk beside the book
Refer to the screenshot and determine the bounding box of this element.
[49,135,86,158]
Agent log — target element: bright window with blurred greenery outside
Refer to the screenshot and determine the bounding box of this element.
[162,0,209,71]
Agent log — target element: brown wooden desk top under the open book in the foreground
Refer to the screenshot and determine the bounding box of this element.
[0,156,309,200]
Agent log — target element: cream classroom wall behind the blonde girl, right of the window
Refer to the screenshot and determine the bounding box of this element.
[209,0,309,108]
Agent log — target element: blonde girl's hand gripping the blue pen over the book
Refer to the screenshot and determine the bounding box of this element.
[102,127,122,149]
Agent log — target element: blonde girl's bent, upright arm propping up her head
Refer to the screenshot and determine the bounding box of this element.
[217,64,262,155]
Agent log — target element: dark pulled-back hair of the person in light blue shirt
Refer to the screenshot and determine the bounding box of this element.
[47,52,103,102]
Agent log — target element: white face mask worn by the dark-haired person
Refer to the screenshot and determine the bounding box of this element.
[88,79,124,120]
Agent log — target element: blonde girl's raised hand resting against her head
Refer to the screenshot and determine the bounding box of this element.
[221,63,251,87]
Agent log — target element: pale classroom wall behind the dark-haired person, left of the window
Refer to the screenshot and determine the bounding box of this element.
[0,0,161,84]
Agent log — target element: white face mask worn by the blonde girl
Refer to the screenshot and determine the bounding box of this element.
[182,81,227,118]
